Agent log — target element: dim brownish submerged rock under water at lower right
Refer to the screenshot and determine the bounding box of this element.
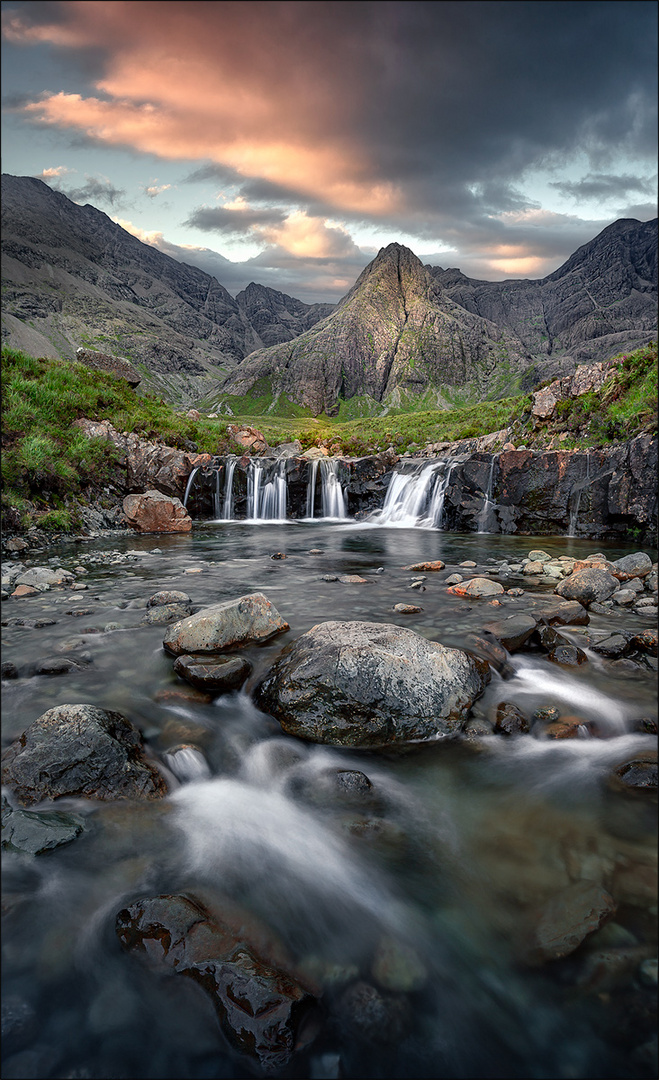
[528,881,616,963]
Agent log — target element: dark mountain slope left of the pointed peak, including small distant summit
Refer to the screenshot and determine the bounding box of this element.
[2,174,333,403]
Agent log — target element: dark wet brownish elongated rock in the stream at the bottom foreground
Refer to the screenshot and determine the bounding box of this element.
[116,895,314,1076]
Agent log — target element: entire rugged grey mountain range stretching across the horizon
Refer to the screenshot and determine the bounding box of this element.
[2,175,657,415]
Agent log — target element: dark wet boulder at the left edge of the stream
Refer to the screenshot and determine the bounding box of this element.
[2,705,166,806]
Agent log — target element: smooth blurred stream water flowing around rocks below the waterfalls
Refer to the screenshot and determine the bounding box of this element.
[2,521,656,1078]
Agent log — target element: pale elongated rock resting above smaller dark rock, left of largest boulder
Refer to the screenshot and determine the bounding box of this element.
[163,593,290,657]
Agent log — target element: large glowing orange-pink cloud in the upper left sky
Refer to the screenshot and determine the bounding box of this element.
[4,0,403,215]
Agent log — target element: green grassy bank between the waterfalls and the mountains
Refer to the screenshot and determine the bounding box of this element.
[2,342,657,530]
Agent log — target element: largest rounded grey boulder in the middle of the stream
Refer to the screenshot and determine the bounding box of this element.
[256,622,489,746]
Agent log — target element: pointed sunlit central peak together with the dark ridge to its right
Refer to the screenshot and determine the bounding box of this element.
[218,220,657,415]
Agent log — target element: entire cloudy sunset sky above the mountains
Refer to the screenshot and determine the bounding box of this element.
[2,0,657,303]
